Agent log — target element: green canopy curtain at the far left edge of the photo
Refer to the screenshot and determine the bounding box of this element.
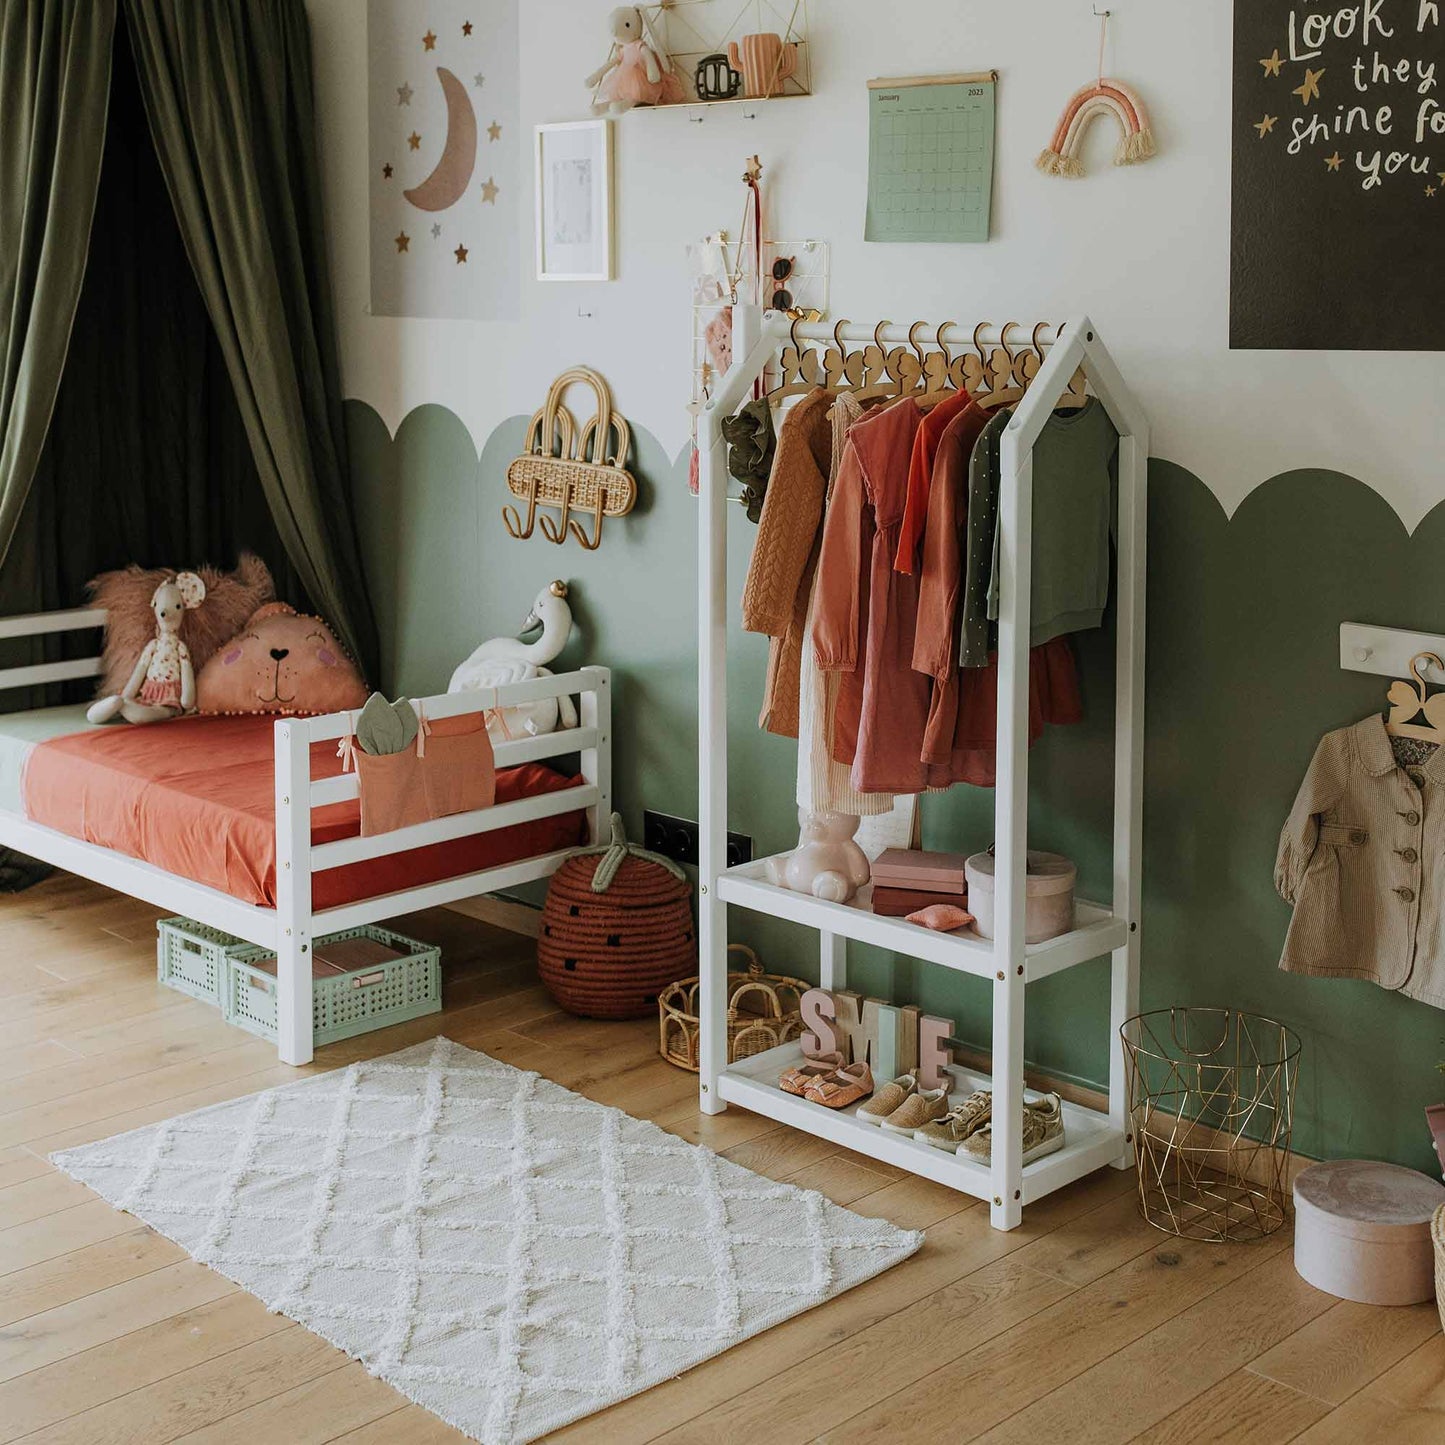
[0,0,116,561]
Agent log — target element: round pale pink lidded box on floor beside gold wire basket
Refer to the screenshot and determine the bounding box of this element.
[1295,1159,1445,1305]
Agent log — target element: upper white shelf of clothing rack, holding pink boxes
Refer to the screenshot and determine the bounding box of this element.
[718,858,1129,983]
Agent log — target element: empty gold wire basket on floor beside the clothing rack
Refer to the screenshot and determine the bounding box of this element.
[1118,1009,1299,1243]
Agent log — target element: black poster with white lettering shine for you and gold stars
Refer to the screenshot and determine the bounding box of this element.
[1230,0,1445,351]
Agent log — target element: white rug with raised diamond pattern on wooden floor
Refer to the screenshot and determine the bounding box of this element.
[52,1039,923,1445]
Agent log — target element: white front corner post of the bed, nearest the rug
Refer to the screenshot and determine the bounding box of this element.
[276,721,312,1064]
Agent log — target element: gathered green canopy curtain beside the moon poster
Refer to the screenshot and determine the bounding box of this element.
[122,0,379,676]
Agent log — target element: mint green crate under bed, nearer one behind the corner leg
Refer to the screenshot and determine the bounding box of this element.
[221,925,442,1048]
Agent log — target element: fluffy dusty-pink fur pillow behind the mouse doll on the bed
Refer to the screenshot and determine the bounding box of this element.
[85,552,276,698]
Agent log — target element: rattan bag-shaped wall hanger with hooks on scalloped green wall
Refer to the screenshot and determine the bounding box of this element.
[501,366,637,552]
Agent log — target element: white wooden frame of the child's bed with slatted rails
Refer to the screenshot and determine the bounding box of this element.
[0,608,613,1064]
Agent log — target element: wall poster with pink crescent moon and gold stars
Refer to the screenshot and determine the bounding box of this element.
[367,0,523,321]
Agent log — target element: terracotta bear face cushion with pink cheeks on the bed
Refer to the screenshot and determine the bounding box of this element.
[195,603,367,715]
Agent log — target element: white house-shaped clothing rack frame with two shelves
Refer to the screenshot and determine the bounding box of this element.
[698,306,1149,1230]
